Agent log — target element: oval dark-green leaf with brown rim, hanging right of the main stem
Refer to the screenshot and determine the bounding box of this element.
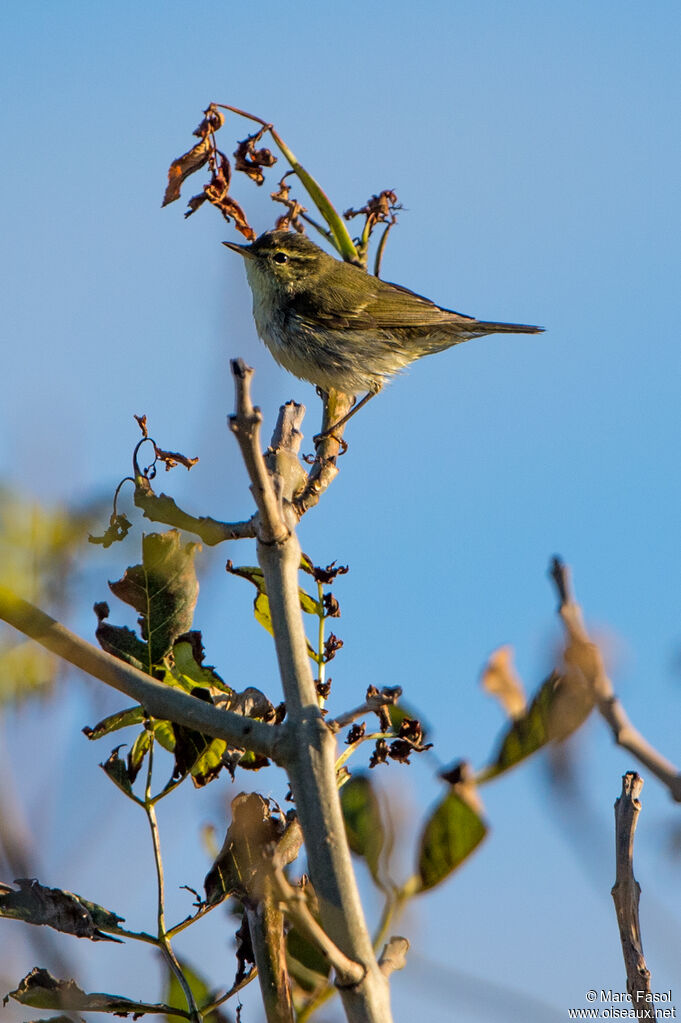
[417,786,487,891]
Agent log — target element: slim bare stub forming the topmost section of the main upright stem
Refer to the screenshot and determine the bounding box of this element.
[229,359,288,543]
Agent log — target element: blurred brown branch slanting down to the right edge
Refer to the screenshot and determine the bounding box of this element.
[550,558,681,803]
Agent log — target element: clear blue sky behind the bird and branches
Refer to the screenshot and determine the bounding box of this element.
[0,0,681,1023]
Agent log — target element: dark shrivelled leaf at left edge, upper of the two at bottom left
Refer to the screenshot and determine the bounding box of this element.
[0,878,125,941]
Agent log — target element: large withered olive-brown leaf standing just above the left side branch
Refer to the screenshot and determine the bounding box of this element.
[108,529,200,665]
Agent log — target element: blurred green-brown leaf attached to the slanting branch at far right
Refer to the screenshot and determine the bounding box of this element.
[478,671,593,783]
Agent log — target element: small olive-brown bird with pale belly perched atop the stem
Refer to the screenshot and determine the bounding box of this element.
[224,230,543,427]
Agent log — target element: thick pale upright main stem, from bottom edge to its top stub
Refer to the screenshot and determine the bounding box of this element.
[230,360,391,1023]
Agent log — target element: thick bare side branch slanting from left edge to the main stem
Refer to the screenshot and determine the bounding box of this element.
[0,586,282,763]
